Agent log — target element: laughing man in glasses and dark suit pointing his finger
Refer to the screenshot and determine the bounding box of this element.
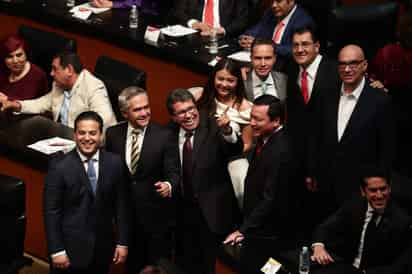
[167,89,243,273]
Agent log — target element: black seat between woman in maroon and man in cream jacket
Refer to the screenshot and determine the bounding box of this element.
[19,25,77,88]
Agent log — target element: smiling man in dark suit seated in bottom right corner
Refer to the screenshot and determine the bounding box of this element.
[312,171,411,274]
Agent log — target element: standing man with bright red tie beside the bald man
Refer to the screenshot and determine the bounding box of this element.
[286,26,340,184]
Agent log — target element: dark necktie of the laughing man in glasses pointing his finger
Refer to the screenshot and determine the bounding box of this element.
[182,131,194,200]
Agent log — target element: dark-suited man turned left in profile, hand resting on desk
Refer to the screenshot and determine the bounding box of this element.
[224,95,295,244]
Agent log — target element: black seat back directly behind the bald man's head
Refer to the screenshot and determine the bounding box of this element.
[328,2,398,59]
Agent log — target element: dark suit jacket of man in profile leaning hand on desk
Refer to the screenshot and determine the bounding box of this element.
[240,129,296,236]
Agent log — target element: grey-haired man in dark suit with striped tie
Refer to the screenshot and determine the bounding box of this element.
[106,86,180,273]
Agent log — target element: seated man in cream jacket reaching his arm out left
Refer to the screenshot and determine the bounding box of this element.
[0,52,116,131]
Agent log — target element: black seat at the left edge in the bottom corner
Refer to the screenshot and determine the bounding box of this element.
[0,175,32,274]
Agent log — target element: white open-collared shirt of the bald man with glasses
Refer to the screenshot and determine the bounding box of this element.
[338,77,365,141]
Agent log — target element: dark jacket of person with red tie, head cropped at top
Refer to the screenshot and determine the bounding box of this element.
[169,0,248,36]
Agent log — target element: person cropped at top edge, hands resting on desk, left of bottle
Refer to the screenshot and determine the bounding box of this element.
[91,0,162,14]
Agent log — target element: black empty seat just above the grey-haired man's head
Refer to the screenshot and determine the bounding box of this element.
[94,55,146,121]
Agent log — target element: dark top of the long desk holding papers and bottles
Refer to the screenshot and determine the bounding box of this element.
[0,0,240,73]
